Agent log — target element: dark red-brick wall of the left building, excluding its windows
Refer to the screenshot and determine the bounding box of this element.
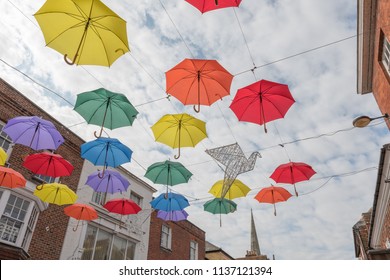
[0,79,84,259]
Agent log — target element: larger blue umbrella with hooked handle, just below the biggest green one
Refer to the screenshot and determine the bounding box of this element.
[81,137,133,177]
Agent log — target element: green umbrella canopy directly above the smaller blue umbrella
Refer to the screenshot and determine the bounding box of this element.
[145,160,192,186]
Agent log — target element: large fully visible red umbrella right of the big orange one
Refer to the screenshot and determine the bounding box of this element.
[230,80,295,132]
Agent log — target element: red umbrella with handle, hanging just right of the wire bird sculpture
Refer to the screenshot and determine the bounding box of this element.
[270,161,316,196]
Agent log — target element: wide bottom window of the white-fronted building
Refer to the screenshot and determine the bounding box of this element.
[81,225,136,260]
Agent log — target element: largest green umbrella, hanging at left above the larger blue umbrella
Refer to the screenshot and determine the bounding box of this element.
[74,88,138,138]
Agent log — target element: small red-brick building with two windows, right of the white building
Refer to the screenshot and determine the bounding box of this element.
[148,211,206,260]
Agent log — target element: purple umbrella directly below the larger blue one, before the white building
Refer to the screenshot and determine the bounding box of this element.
[85,170,130,193]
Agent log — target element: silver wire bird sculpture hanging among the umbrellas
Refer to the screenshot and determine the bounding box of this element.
[206,143,261,198]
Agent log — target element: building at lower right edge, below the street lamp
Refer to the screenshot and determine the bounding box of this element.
[352,144,390,260]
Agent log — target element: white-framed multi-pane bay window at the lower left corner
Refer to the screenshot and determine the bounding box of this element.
[0,190,39,251]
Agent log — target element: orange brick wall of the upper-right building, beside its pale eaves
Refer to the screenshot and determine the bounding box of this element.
[372,0,390,128]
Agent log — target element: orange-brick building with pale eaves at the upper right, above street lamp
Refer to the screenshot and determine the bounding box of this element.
[357,0,390,128]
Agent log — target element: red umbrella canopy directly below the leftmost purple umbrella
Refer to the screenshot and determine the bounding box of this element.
[23,152,74,178]
